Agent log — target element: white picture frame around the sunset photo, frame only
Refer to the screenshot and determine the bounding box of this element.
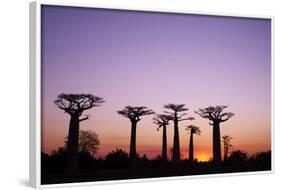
[29,1,274,188]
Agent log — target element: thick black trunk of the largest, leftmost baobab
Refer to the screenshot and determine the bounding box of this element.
[66,114,79,175]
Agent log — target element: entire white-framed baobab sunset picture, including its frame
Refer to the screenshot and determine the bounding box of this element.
[30,2,273,187]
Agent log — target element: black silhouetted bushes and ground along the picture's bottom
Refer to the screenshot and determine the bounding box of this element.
[41,148,271,184]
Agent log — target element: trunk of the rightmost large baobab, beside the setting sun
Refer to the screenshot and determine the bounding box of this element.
[213,123,222,166]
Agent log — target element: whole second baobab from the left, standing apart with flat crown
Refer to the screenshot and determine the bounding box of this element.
[117,106,154,169]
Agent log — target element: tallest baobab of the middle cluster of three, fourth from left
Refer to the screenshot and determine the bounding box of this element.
[164,103,194,162]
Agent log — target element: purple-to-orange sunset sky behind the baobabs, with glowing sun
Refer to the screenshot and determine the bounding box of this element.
[42,6,271,160]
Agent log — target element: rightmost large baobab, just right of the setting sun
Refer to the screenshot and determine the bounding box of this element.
[195,105,234,165]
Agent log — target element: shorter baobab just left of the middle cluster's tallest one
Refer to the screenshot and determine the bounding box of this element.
[153,114,172,161]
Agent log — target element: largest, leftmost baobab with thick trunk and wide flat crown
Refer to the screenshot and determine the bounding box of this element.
[54,94,104,175]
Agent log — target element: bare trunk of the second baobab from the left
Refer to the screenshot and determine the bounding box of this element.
[129,122,137,169]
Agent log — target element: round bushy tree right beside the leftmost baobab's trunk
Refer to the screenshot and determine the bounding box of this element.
[79,130,100,157]
